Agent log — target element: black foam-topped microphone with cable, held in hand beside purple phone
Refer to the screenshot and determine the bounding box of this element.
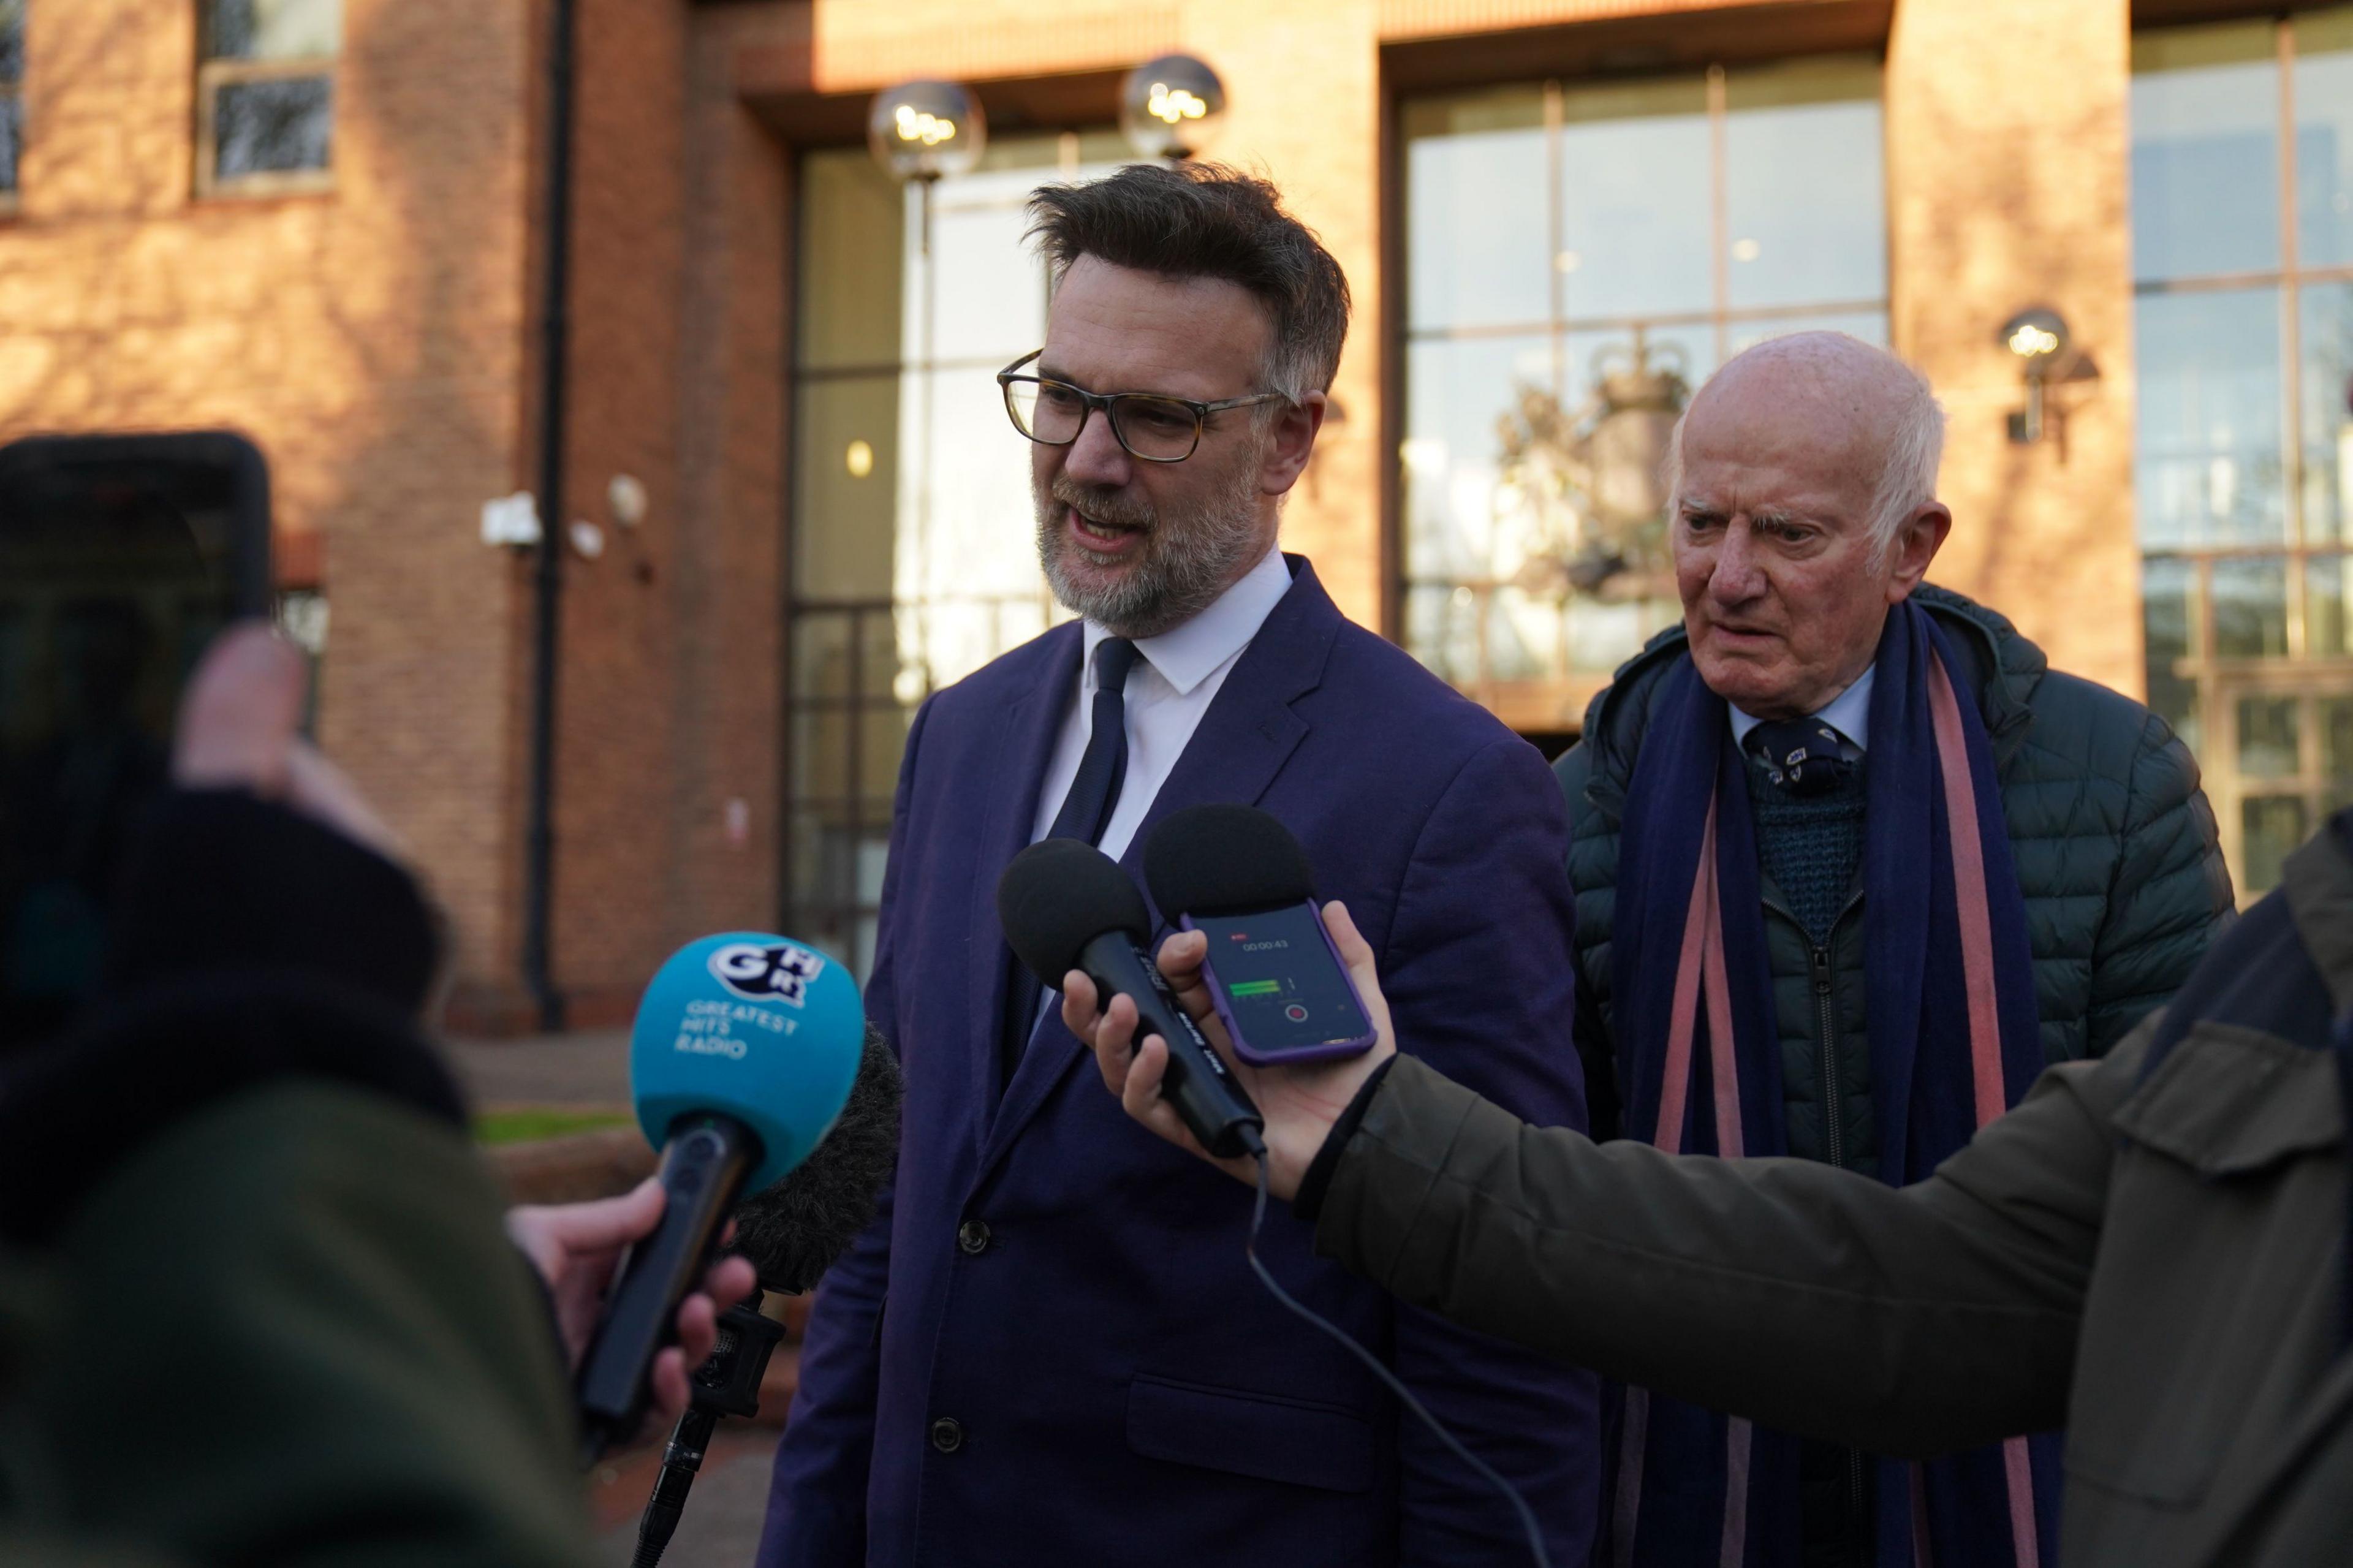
[998,838,1266,1158]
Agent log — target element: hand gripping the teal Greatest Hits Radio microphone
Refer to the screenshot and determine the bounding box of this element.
[506,1177,760,1422]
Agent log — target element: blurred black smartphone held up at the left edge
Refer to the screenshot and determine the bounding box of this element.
[0,431,271,1050]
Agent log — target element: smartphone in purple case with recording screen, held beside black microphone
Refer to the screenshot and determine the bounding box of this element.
[1179,902,1374,1067]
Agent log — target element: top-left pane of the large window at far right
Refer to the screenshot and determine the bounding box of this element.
[2132,21,2280,278]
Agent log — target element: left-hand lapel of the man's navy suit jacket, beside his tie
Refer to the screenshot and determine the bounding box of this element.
[964,621,1085,1140]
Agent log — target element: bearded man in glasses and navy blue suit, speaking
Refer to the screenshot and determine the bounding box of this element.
[760,165,1597,1568]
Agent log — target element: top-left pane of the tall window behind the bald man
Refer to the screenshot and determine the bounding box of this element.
[1404,85,1553,327]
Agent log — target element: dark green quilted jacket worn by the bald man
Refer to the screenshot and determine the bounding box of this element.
[1553,586,2233,1153]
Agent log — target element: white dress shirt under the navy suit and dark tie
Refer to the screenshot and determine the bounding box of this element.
[1031,546,1292,859]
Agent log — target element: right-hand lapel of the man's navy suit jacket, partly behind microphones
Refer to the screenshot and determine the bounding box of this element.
[979,556,1341,1180]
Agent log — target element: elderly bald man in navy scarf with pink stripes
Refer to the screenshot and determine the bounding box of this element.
[1558,332,2233,1568]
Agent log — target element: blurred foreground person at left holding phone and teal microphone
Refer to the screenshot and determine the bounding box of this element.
[0,626,753,1568]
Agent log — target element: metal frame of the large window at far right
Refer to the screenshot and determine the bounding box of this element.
[2132,14,2353,890]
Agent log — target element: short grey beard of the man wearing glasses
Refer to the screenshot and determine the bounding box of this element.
[1033,445,1264,638]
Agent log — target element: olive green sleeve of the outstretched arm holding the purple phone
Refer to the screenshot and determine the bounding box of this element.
[1316,1031,2139,1455]
